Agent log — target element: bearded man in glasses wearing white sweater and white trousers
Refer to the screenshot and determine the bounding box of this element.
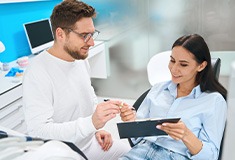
[23,0,130,160]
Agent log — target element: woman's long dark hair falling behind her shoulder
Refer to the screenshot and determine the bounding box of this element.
[172,34,227,99]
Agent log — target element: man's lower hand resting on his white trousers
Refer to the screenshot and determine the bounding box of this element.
[95,130,113,151]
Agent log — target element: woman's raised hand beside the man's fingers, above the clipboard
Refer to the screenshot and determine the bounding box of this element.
[120,103,136,121]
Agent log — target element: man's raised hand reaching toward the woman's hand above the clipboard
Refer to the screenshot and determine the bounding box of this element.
[92,100,121,129]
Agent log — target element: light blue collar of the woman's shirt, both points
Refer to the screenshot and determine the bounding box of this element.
[165,81,202,98]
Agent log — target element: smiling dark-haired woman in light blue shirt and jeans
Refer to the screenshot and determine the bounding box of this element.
[120,34,227,160]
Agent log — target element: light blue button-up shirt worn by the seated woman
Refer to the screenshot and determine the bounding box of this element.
[137,81,227,160]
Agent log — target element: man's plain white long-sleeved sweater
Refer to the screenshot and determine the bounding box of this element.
[23,51,97,149]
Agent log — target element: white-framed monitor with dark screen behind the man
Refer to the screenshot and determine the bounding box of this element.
[23,19,54,54]
